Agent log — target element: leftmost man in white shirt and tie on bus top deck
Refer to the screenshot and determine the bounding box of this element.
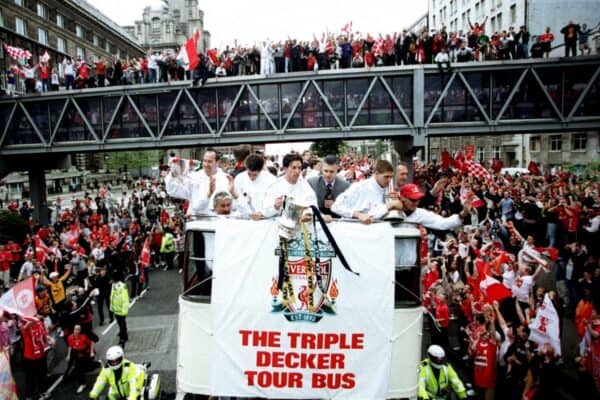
[165,149,229,215]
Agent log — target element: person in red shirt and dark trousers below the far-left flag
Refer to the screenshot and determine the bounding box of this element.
[19,317,50,398]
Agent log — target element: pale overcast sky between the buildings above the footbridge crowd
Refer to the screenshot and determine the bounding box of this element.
[88,0,427,47]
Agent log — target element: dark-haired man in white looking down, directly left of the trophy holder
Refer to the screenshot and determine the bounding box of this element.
[233,154,277,219]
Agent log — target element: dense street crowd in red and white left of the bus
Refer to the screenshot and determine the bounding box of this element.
[0,179,188,399]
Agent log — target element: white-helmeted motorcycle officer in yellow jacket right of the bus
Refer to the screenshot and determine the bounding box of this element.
[417,344,467,400]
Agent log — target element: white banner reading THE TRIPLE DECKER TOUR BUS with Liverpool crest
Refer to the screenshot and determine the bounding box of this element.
[211,220,394,399]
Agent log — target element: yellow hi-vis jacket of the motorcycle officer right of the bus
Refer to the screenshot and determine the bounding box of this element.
[417,359,467,400]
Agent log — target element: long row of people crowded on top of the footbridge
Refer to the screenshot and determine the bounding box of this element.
[5,18,598,95]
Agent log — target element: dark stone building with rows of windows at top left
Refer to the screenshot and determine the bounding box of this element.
[0,0,144,71]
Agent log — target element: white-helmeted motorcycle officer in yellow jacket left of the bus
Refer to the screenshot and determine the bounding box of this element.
[90,346,146,400]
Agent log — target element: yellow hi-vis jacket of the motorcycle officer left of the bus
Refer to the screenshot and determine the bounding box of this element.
[90,360,146,400]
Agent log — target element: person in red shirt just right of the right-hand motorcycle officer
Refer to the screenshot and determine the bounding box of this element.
[469,329,497,399]
